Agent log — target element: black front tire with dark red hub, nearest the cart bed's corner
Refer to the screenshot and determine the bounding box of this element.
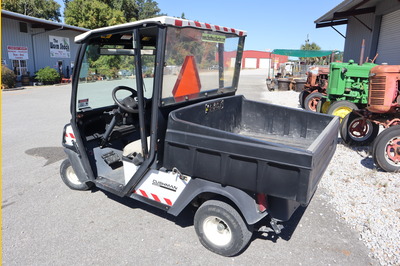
[340,112,379,146]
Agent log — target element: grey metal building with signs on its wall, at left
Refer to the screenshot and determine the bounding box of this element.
[1,10,87,79]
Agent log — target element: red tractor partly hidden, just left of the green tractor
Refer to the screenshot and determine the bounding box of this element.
[299,66,329,112]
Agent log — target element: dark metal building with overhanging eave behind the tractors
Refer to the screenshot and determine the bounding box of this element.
[315,0,400,65]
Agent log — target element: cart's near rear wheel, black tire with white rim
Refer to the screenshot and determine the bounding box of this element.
[194,200,253,257]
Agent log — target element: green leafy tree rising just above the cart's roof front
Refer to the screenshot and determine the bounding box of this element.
[64,0,126,29]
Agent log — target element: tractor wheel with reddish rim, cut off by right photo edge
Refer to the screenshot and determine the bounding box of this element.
[372,125,400,173]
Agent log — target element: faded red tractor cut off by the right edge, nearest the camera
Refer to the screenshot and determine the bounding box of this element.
[340,65,400,172]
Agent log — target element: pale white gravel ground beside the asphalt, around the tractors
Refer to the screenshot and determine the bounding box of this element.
[262,91,400,265]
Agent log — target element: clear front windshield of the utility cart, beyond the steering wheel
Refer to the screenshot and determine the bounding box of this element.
[76,33,155,111]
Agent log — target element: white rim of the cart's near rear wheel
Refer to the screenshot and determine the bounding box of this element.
[203,216,232,246]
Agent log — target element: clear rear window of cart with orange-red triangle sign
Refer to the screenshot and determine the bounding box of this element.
[162,27,239,105]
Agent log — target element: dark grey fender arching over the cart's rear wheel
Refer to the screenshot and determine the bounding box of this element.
[168,178,268,225]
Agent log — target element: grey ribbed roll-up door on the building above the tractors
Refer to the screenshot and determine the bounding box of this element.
[376,9,400,65]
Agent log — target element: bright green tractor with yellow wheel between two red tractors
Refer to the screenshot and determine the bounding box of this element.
[318,60,376,119]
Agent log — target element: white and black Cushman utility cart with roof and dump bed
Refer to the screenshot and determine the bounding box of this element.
[60,17,339,256]
